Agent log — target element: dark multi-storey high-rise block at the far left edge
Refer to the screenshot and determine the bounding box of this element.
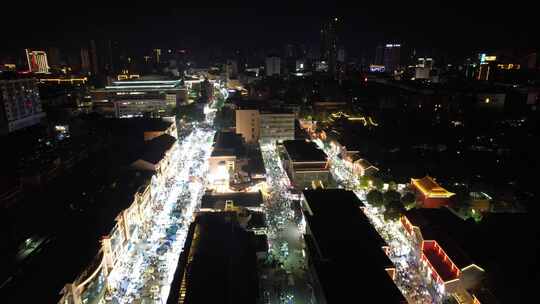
[0,78,45,134]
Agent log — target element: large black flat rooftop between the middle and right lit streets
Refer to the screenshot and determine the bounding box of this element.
[303,189,406,303]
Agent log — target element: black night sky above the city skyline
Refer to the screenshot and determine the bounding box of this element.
[0,1,539,57]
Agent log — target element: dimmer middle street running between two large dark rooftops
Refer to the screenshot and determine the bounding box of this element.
[261,143,313,303]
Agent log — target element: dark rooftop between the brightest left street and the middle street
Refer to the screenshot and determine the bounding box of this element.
[185,212,258,304]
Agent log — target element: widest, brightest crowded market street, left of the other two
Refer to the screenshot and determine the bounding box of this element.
[105,126,214,303]
